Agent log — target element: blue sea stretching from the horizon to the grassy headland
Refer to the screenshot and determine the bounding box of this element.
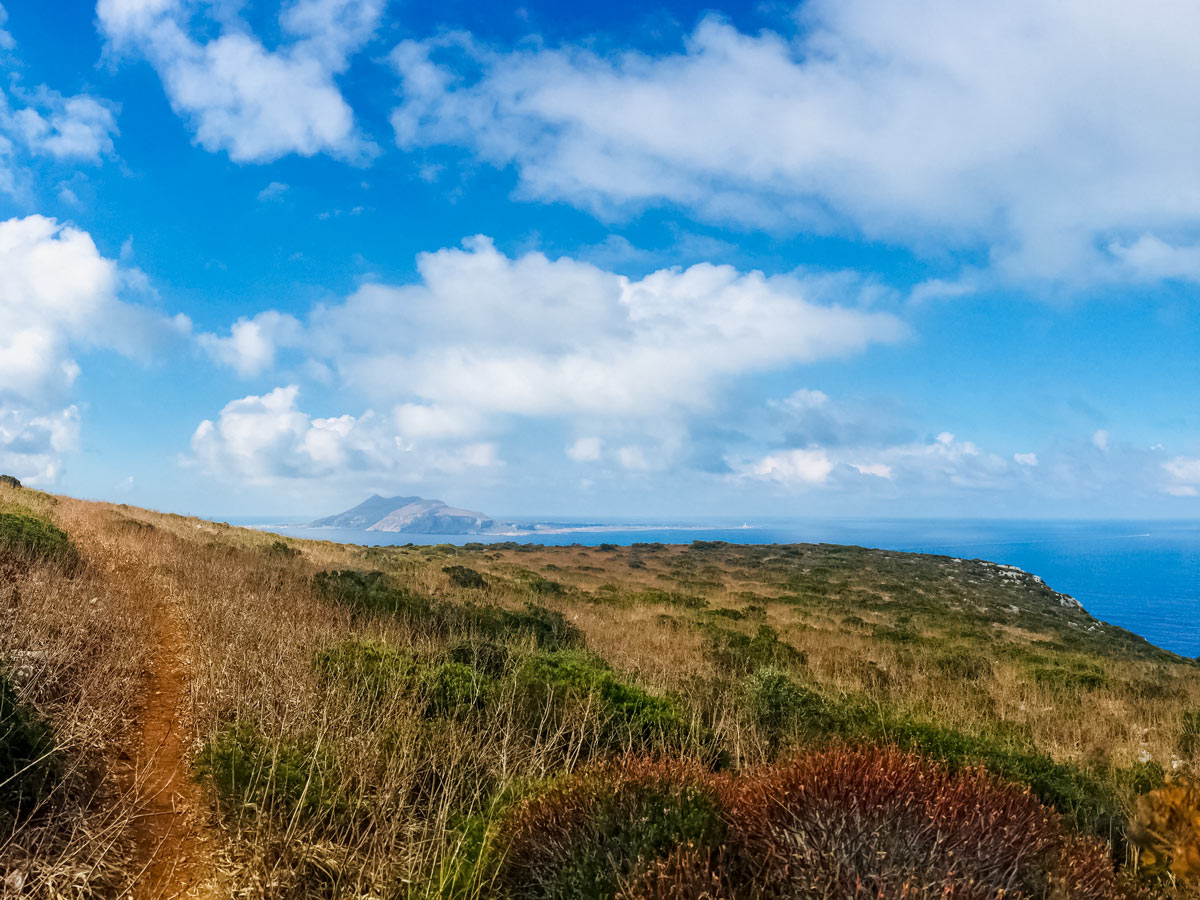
[244,518,1200,656]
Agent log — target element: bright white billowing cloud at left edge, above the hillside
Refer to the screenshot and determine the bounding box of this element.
[0,216,188,484]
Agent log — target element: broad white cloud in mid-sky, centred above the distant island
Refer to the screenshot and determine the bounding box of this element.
[310,238,906,418]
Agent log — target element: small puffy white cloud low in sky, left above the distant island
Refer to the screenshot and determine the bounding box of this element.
[191,385,503,485]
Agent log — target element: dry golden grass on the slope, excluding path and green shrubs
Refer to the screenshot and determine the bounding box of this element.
[0,487,1200,898]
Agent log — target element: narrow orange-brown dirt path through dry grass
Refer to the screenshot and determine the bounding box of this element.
[127,600,220,900]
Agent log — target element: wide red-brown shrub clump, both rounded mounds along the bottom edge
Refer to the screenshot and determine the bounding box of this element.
[498,748,1121,900]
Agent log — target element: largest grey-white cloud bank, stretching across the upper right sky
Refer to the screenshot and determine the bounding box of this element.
[391,0,1200,280]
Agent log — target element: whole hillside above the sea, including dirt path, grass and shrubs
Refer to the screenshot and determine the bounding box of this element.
[0,485,1200,900]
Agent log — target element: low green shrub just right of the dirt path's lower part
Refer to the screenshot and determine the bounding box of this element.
[196,722,352,824]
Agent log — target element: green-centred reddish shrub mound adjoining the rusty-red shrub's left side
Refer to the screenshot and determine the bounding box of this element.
[496,758,722,900]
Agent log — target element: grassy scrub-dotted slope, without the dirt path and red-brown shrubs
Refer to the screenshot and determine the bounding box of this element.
[0,487,1200,895]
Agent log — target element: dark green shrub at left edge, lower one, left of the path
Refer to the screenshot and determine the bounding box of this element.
[0,671,62,822]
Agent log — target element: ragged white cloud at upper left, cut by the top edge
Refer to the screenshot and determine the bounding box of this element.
[96,0,383,162]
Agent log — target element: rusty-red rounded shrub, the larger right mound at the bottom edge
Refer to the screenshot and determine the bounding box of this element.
[722,748,1117,900]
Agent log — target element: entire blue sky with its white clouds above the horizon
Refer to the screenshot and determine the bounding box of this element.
[0,0,1200,518]
